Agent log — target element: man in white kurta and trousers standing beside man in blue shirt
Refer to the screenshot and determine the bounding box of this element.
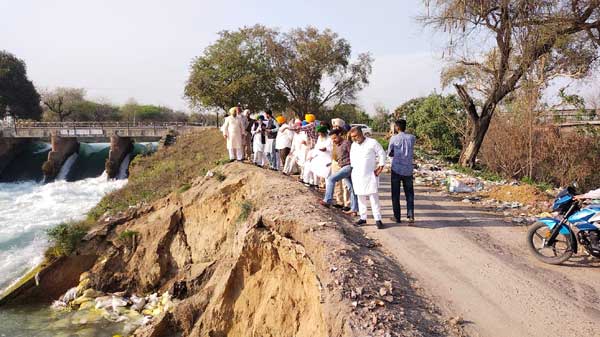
[350,128,386,228]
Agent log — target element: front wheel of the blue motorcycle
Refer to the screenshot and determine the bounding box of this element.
[527,222,573,264]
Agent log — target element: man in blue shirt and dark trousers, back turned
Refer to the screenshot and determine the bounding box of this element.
[388,119,415,223]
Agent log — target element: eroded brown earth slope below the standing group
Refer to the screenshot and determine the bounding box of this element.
[71,163,449,337]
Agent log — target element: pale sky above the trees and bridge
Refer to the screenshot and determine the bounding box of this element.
[0,0,442,112]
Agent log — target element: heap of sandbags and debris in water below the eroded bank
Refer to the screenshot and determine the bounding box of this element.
[51,273,174,334]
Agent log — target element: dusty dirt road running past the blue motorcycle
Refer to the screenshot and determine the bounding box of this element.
[366,175,600,336]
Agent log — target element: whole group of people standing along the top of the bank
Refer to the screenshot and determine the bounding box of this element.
[221,107,415,228]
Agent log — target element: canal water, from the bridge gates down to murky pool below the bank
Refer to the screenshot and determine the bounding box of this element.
[0,143,156,337]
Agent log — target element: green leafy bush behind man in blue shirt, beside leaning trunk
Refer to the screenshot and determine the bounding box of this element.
[394,94,467,159]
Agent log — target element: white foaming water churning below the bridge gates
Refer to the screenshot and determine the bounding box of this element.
[0,174,127,289]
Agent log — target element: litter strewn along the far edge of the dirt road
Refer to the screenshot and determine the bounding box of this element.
[415,158,558,225]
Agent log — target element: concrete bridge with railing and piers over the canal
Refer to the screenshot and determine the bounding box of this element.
[0,120,198,180]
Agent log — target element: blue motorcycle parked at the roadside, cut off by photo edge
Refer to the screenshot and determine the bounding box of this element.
[527,186,600,264]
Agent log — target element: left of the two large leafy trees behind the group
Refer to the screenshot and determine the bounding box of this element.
[185,25,287,124]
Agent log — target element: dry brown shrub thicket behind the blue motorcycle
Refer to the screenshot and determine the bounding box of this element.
[480,115,600,189]
